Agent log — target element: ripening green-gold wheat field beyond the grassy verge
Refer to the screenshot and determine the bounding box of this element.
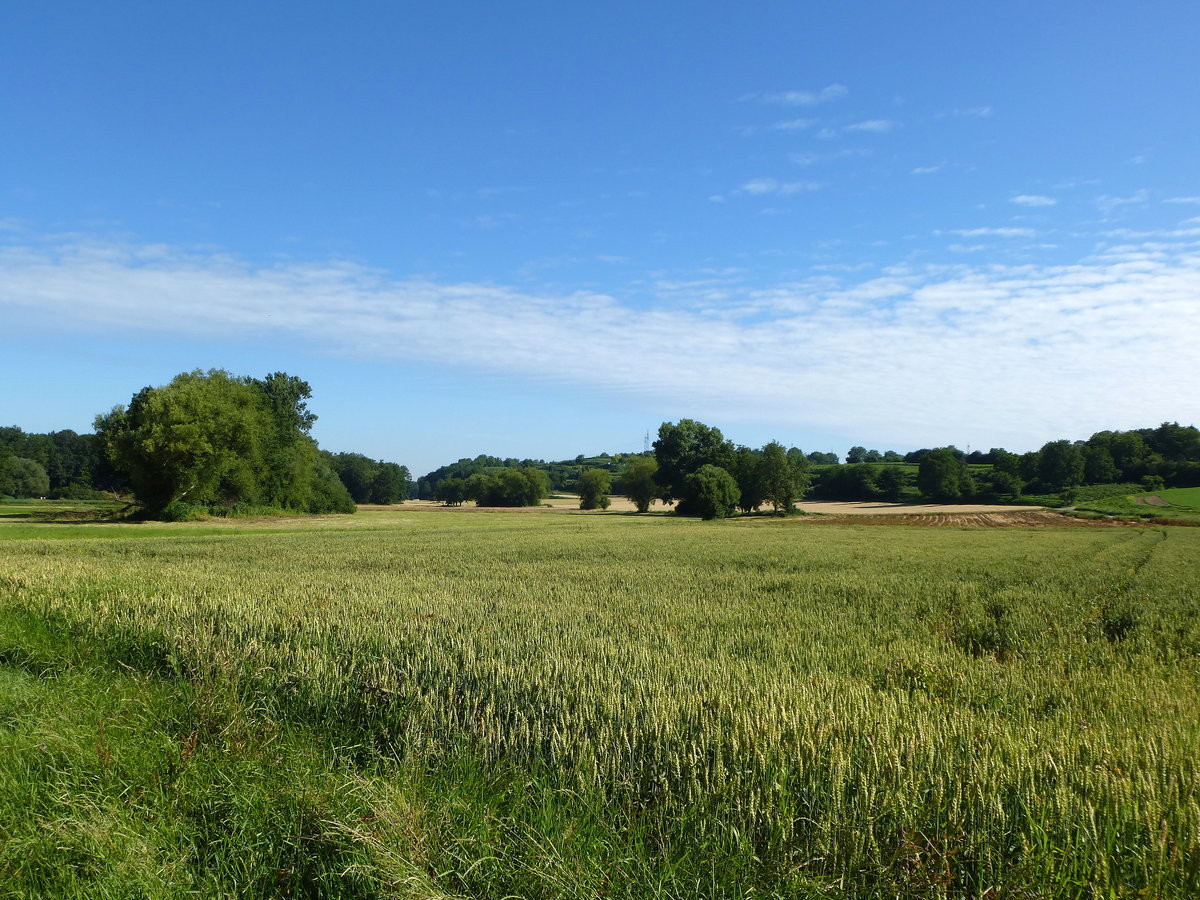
[0,509,1200,898]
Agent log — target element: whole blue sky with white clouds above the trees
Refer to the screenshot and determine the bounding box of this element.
[0,0,1200,474]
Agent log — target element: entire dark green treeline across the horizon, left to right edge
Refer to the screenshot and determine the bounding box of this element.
[11,370,1200,518]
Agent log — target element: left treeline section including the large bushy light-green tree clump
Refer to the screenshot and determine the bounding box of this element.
[0,370,413,518]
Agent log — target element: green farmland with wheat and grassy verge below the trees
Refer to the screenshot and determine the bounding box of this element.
[0,509,1200,898]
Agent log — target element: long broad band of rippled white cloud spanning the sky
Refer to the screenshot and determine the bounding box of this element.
[0,237,1200,449]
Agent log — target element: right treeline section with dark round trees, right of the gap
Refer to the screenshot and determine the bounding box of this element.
[418,419,1200,518]
